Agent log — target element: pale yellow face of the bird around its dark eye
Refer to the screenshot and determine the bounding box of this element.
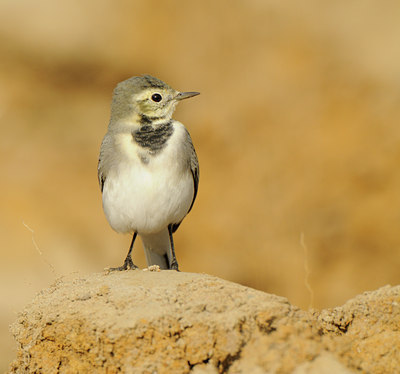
[133,87,179,118]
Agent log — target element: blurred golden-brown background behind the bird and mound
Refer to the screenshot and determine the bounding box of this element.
[0,0,400,369]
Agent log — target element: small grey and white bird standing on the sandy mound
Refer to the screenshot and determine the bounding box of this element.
[98,75,199,270]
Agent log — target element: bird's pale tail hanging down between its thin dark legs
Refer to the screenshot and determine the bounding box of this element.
[140,228,172,269]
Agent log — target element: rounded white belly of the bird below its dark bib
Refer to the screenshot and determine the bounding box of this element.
[103,131,194,234]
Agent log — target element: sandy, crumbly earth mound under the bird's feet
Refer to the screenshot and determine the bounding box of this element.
[7,271,400,374]
